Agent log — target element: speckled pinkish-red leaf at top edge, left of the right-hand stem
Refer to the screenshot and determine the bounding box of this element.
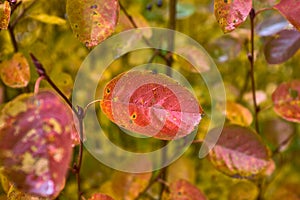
[214,0,252,33]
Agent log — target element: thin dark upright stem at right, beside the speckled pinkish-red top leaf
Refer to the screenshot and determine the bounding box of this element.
[248,8,260,133]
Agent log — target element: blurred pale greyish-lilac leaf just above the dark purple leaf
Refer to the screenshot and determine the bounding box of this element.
[255,14,289,37]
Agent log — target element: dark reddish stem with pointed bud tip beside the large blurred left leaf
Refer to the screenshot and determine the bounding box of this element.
[30,53,84,200]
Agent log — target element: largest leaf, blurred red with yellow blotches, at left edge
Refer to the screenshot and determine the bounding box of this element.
[0,91,74,198]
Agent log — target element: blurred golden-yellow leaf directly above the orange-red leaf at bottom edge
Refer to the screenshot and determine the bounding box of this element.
[167,157,196,183]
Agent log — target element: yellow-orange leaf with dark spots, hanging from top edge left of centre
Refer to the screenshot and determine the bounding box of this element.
[67,0,119,48]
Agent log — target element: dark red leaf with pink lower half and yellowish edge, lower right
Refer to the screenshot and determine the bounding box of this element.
[208,125,271,179]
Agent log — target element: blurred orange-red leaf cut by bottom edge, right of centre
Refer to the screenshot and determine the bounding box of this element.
[162,179,206,200]
